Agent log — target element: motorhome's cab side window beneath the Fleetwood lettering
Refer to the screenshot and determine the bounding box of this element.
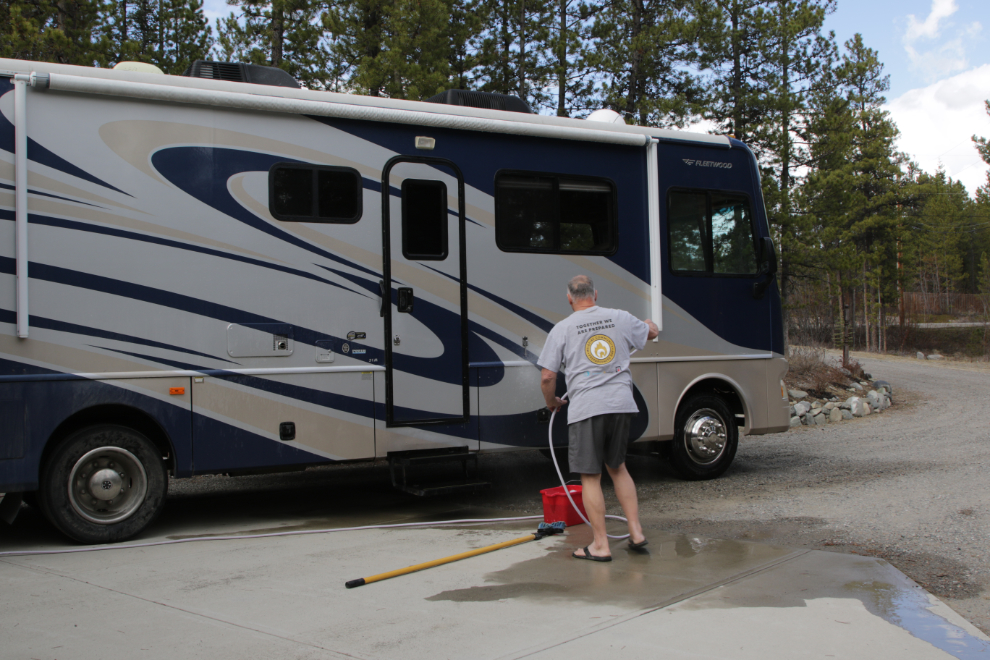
[667,190,757,275]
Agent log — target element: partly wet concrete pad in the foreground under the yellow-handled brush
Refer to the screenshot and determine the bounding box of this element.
[0,510,990,660]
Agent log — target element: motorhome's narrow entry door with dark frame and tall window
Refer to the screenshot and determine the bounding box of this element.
[382,156,470,427]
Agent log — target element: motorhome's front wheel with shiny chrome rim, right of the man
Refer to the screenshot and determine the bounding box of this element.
[664,394,739,481]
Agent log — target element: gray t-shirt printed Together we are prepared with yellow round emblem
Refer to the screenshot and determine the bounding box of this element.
[536,306,650,424]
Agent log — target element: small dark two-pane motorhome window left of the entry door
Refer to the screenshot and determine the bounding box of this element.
[268,163,362,224]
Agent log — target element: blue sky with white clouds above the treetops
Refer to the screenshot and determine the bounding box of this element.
[204,0,990,194]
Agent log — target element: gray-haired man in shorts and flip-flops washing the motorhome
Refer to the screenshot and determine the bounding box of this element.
[537,275,660,561]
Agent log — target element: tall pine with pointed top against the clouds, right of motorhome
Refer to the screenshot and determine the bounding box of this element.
[804,35,913,348]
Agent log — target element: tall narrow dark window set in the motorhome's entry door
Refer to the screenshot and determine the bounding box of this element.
[402,179,447,261]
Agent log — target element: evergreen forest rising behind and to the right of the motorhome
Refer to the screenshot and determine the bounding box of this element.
[0,0,990,359]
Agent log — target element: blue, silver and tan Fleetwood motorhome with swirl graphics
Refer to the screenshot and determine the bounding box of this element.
[0,60,789,543]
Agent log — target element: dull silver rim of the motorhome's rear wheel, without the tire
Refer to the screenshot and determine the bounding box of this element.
[69,447,148,525]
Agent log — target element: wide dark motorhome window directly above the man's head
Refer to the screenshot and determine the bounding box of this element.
[495,172,616,254]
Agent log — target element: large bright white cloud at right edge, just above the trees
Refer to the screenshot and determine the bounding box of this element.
[886,64,990,193]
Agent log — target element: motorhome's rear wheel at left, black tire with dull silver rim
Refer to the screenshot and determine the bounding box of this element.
[38,424,168,543]
